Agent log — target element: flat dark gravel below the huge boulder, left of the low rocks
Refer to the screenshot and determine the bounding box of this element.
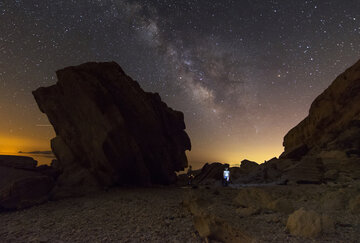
[0,187,202,242]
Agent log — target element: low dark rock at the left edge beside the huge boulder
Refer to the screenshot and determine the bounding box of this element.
[0,156,55,210]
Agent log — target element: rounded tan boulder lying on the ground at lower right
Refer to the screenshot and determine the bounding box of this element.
[286,208,335,238]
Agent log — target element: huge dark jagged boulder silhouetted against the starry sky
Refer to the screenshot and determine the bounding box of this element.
[33,62,191,194]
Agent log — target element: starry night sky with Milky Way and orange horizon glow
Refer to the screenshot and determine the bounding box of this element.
[0,0,360,164]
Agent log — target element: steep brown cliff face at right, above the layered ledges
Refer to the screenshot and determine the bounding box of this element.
[281,61,360,159]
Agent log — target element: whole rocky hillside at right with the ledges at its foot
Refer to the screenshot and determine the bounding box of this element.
[190,61,360,184]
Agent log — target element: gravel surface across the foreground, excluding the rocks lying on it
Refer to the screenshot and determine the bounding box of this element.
[0,186,360,243]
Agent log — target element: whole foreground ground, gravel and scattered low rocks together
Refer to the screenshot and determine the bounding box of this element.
[0,184,360,242]
